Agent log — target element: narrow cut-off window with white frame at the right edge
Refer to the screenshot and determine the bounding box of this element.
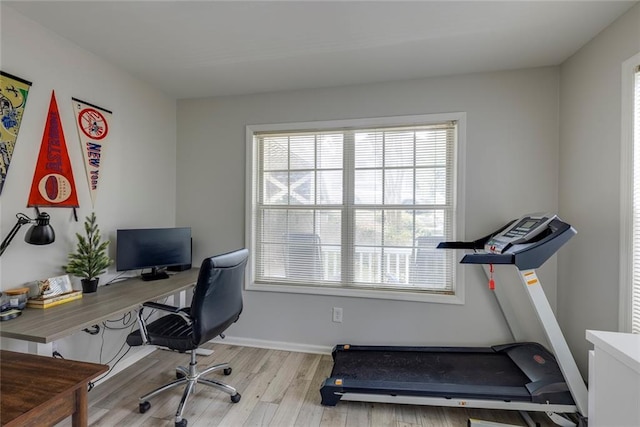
[620,53,640,333]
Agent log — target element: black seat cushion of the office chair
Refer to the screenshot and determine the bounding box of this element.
[127,314,198,352]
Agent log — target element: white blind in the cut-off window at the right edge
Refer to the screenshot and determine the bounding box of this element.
[631,66,640,333]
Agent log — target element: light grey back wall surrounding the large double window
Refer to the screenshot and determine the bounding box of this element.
[177,67,569,347]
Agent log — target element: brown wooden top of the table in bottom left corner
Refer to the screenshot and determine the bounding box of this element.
[0,350,109,425]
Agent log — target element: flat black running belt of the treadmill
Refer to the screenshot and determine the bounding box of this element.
[331,351,529,387]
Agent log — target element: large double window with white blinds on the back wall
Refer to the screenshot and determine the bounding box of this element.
[247,114,464,302]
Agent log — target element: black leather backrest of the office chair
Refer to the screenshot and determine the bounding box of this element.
[190,249,249,345]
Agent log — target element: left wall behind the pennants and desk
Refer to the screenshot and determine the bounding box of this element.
[0,4,176,360]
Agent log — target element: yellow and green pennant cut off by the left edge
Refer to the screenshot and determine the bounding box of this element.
[0,71,31,193]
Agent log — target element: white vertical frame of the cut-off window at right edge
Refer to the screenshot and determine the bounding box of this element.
[618,52,640,332]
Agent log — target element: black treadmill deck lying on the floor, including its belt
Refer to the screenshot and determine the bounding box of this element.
[320,343,574,405]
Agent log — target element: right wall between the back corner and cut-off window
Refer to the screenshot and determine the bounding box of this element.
[558,5,640,373]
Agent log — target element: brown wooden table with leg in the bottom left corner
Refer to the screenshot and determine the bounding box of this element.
[0,350,109,427]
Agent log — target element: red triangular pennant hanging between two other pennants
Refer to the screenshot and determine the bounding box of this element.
[27,91,79,208]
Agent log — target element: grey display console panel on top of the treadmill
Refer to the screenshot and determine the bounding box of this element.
[484,214,557,254]
